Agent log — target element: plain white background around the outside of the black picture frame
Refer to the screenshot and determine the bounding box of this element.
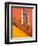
[0,0,38,46]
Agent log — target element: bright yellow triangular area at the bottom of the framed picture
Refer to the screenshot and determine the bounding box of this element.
[12,25,30,38]
